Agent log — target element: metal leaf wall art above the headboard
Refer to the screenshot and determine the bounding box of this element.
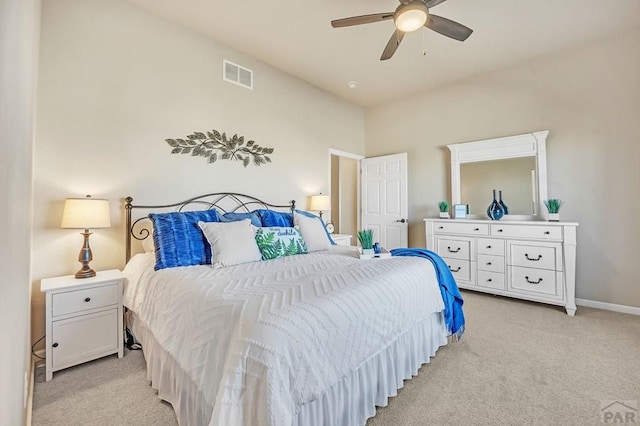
[165,130,273,167]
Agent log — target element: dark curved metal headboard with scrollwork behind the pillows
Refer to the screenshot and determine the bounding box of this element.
[124,192,296,262]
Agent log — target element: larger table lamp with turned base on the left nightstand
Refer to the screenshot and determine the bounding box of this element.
[60,195,111,278]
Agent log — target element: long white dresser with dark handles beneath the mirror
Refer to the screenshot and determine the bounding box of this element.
[424,219,578,316]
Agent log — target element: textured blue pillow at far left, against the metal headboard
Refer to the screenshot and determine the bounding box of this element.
[149,209,219,271]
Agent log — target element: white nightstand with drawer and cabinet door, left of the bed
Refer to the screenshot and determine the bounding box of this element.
[40,269,124,381]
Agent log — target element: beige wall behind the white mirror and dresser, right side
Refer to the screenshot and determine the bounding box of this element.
[366,31,640,307]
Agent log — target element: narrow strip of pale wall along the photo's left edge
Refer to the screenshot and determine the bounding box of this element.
[0,0,40,425]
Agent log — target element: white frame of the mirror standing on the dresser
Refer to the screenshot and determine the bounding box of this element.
[447,130,549,220]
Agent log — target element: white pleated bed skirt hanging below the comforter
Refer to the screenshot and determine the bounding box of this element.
[129,312,447,426]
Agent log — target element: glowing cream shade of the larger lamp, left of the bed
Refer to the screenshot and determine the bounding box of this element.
[60,197,111,229]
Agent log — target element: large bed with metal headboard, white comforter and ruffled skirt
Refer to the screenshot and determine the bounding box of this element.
[123,193,462,426]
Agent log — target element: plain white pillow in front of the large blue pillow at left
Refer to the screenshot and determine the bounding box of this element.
[198,219,262,268]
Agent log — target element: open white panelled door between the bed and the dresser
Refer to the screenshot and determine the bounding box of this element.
[361,152,409,250]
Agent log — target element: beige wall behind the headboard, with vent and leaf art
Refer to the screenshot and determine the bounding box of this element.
[33,0,364,346]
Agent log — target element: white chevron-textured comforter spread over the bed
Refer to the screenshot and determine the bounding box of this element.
[124,247,444,426]
